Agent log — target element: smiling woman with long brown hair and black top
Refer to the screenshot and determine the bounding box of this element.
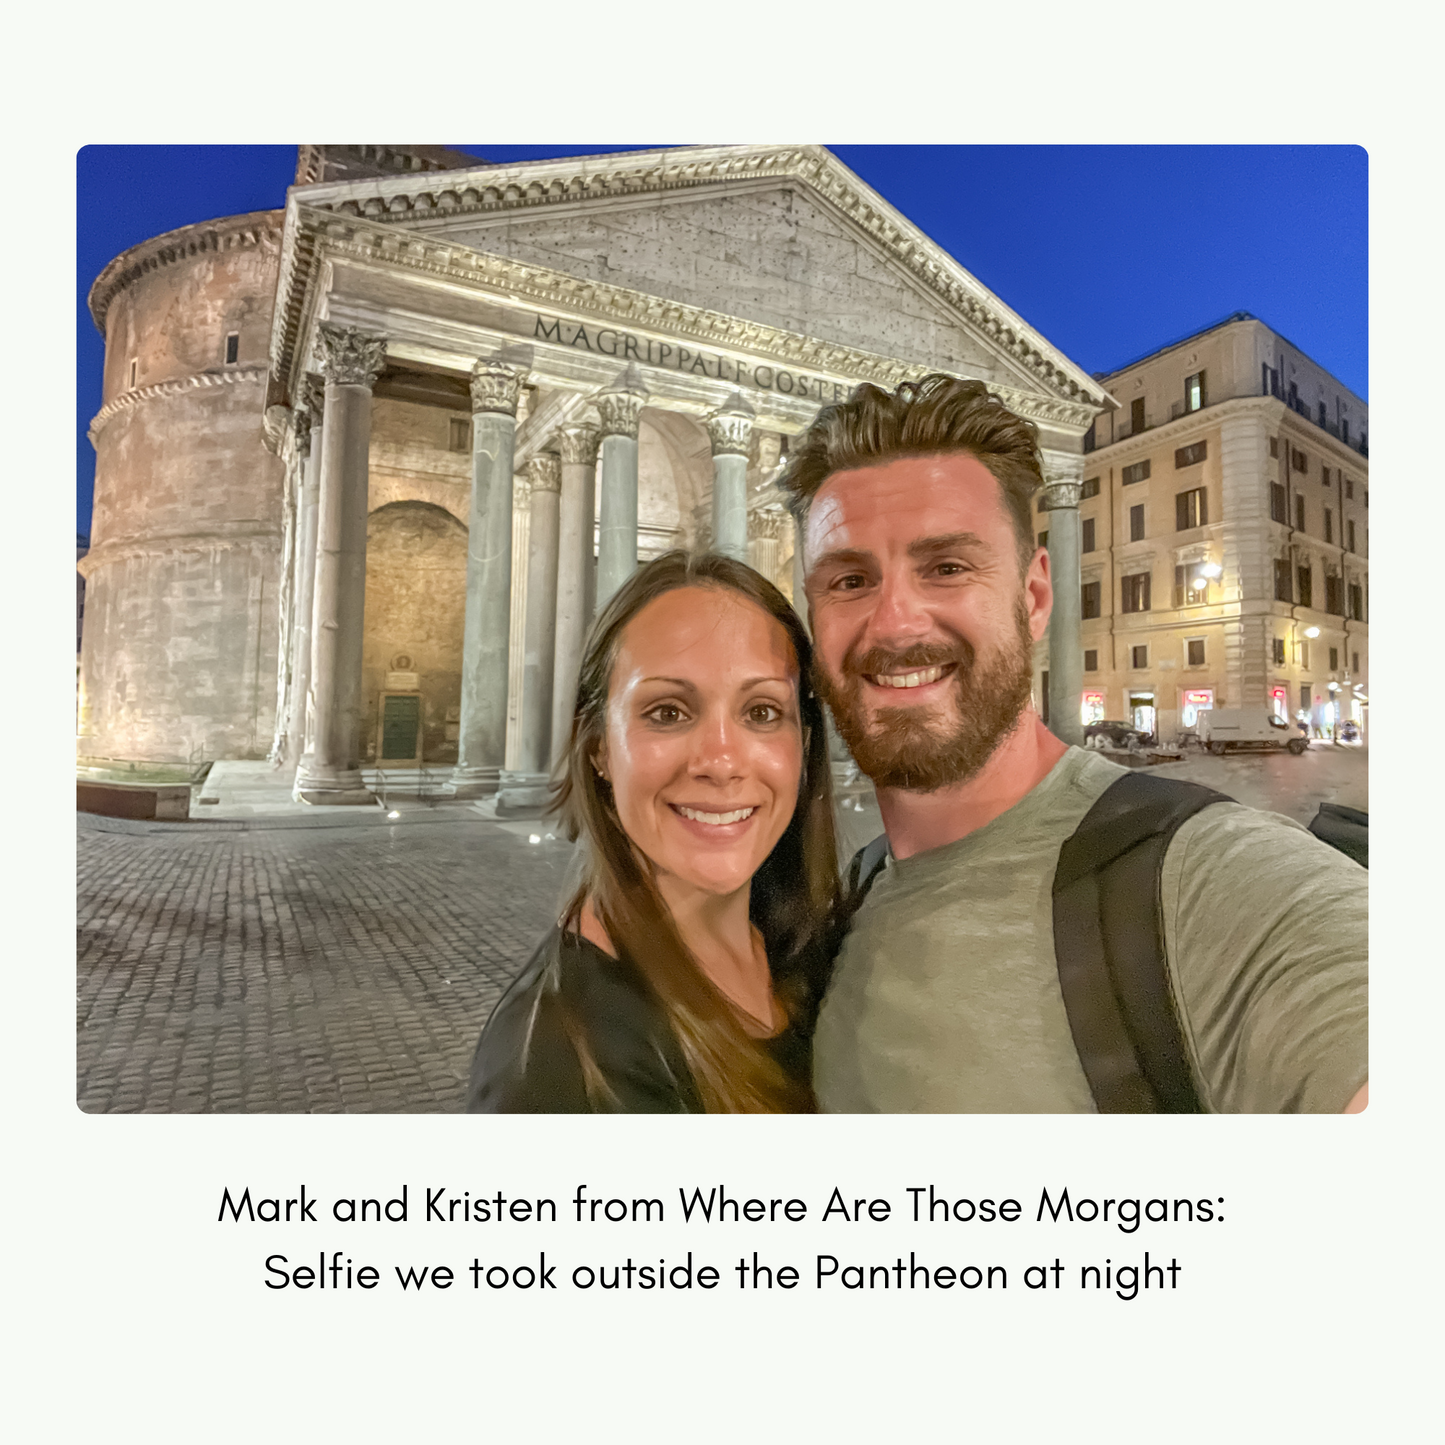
[468,552,838,1113]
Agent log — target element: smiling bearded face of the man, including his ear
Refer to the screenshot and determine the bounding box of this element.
[803,454,1053,792]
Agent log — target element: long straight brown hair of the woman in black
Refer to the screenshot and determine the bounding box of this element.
[552,552,838,1113]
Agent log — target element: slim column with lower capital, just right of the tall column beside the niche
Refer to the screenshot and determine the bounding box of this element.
[497,452,562,814]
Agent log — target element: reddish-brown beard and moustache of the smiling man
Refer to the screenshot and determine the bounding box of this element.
[814,598,1033,793]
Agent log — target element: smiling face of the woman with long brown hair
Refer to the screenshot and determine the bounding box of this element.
[595,587,803,897]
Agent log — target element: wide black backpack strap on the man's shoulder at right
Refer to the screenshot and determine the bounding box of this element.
[1053,772,1233,1114]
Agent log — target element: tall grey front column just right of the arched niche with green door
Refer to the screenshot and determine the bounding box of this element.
[449,360,526,798]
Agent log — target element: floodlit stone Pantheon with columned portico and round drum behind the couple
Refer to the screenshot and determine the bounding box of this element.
[81,146,1111,802]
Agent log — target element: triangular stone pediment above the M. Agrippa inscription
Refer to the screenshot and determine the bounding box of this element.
[293,146,1107,406]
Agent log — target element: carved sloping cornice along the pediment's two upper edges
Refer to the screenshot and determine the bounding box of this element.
[288,146,1117,412]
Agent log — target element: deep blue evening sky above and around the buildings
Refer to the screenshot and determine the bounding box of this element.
[77,143,1370,532]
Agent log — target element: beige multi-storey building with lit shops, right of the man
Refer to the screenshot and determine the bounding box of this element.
[1038,312,1370,740]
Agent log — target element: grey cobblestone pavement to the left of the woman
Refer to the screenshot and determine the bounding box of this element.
[77,811,571,1113]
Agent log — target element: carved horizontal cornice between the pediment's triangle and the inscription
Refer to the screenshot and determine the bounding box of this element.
[270,207,1098,431]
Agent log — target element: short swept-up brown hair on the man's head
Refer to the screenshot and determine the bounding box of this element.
[777,371,1043,568]
